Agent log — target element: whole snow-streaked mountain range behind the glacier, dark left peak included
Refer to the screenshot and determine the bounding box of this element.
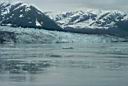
[0,3,128,37]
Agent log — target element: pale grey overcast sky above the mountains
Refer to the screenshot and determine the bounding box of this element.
[0,0,128,11]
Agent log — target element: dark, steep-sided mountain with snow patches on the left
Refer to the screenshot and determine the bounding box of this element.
[0,2,60,30]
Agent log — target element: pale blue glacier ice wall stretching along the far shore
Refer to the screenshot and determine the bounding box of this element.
[0,26,127,44]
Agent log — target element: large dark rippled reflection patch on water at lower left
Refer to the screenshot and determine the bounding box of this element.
[0,59,50,73]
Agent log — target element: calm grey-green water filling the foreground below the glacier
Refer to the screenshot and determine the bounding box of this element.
[0,42,128,86]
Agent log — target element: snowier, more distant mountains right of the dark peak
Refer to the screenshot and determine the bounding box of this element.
[45,9,128,37]
